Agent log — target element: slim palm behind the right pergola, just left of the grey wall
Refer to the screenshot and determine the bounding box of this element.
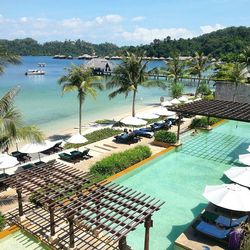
[190,52,211,96]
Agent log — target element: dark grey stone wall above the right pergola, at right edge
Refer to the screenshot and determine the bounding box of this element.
[215,82,250,103]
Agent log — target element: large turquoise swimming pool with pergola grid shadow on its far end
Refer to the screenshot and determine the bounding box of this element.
[116,121,250,250]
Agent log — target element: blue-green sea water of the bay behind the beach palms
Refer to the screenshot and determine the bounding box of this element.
[0,56,197,133]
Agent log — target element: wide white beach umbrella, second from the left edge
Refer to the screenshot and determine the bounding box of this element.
[19,140,57,160]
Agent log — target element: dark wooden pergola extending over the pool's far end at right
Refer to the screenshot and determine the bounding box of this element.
[168,100,250,143]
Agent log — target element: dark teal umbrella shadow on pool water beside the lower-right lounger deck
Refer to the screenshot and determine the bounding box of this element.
[166,203,207,250]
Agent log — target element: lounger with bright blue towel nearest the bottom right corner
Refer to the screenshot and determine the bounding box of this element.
[192,220,231,241]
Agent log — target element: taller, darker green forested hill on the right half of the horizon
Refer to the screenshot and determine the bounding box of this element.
[125,27,250,57]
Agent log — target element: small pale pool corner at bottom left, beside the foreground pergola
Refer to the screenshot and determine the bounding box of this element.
[0,230,49,250]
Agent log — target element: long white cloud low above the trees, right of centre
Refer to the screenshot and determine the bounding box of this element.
[122,27,195,43]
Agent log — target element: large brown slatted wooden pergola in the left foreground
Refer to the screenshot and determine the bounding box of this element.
[5,161,164,250]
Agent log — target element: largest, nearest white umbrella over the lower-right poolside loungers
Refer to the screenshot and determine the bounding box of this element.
[203,184,250,212]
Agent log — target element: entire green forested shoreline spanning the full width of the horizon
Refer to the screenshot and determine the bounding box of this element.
[0,27,250,57]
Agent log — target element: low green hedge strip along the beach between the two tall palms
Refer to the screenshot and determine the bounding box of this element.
[64,128,122,149]
